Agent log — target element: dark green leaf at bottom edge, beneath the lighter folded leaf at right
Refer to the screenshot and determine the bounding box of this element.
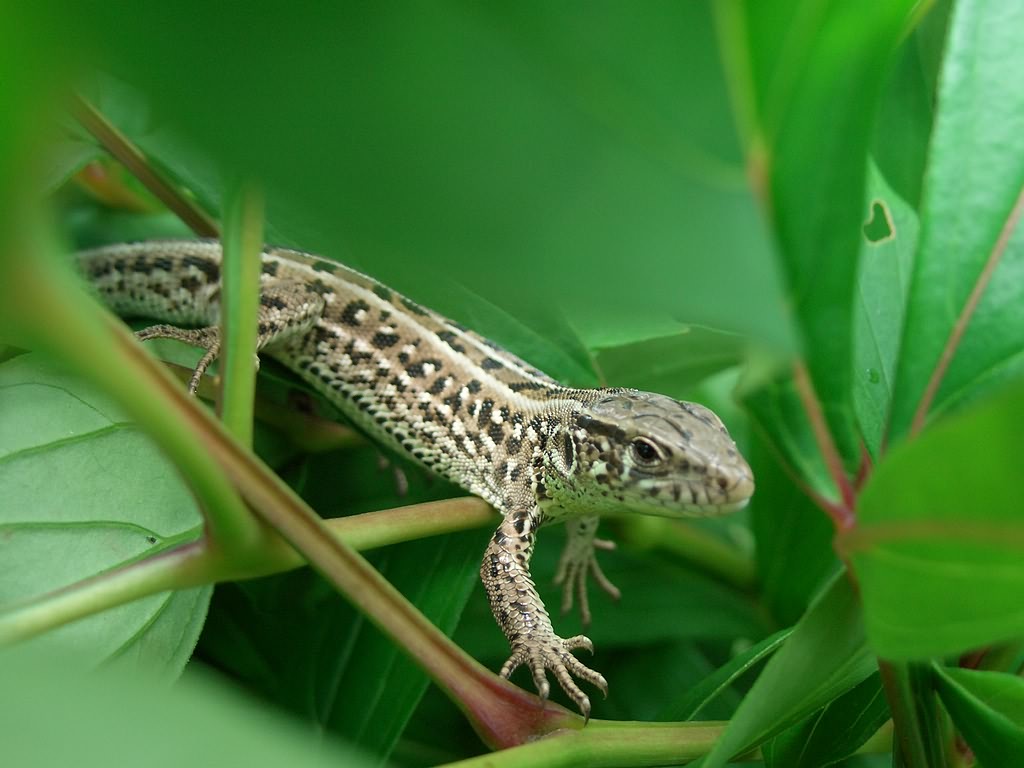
[762,674,889,768]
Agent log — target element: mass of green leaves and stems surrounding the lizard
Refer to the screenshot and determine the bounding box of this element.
[0,0,1024,768]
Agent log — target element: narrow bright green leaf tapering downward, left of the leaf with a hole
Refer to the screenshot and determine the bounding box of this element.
[741,0,914,462]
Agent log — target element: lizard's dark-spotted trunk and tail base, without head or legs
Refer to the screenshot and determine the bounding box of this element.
[79,241,597,509]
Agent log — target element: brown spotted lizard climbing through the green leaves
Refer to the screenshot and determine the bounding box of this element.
[77,241,754,719]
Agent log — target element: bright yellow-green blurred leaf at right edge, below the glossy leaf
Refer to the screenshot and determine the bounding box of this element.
[840,384,1024,658]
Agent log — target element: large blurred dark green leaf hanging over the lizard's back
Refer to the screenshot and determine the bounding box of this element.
[61,0,788,362]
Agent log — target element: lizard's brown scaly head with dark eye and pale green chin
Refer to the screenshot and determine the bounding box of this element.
[552,389,754,517]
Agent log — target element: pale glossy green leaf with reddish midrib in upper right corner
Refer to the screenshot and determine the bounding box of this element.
[892,0,1024,438]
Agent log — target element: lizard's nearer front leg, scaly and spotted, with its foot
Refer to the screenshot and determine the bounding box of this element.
[480,505,608,719]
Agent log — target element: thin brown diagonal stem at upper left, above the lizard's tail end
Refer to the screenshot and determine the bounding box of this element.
[71,94,220,238]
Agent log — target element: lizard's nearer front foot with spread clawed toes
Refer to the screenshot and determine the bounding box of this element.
[500,634,608,720]
